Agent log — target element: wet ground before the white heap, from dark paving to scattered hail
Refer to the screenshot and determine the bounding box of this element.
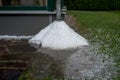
[0,40,116,80]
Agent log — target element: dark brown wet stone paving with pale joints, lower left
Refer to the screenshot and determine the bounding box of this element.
[0,40,36,80]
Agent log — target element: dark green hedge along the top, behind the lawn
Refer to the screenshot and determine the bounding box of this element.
[64,0,120,11]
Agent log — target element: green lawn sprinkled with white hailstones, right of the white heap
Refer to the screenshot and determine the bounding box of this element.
[68,11,120,80]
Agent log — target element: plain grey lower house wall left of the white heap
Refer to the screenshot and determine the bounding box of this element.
[0,11,64,36]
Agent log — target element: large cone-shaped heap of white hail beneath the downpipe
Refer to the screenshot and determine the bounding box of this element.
[29,21,89,50]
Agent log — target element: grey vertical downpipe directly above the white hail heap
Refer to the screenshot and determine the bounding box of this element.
[56,0,62,20]
